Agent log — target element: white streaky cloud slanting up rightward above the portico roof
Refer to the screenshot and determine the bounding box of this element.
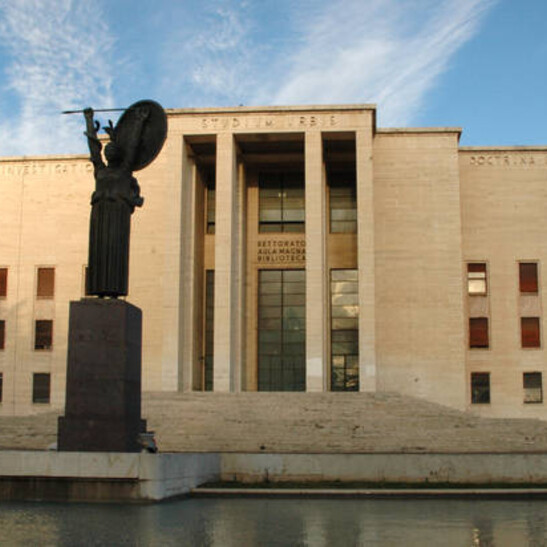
[252,0,495,126]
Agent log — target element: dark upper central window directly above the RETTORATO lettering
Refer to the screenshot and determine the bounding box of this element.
[258,173,305,232]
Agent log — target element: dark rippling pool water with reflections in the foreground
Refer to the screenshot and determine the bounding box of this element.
[0,498,547,547]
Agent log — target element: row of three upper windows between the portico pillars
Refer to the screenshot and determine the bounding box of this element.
[205,172,357,234]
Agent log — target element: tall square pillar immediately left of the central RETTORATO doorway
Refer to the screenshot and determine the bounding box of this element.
[213,133,242,392]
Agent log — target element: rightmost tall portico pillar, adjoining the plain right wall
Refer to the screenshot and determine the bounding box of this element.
[355,129,376,391]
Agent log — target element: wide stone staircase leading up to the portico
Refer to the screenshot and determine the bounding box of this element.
[0,393,547,453]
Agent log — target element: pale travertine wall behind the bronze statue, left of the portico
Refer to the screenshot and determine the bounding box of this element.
[0,143,181,414]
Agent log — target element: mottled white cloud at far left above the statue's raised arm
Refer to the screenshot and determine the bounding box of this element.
[0,0,114,155]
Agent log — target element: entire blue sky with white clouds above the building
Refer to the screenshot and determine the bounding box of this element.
[0,0,547,156]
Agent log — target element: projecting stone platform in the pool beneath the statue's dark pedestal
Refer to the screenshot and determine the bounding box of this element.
[0,451,220,502]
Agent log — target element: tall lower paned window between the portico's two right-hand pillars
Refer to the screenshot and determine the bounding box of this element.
[330,270,359,391]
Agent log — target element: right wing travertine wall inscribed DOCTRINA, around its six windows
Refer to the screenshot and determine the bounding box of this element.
[460,147,547,419]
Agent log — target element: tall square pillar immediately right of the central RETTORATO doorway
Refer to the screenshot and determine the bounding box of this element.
[305,131,328,391]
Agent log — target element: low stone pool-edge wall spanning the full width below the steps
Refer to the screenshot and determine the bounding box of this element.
[0,451,547,502]
